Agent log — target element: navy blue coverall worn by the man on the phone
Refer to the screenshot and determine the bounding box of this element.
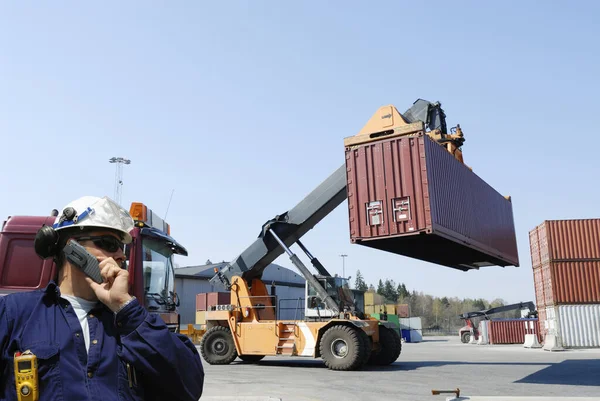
[0,282,204,401]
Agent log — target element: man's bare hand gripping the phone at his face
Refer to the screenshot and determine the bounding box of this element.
[86,257,132,312]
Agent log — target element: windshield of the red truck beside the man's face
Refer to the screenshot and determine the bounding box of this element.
[142,237,174,309]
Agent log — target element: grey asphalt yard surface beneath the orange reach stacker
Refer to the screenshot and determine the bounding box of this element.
[201,336,600,401]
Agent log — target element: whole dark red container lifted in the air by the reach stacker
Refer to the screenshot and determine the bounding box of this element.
[346,132,519,270]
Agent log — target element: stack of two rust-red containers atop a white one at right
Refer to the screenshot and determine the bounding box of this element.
[529,219,600,348]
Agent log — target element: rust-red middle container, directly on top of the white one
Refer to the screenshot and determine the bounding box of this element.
[533,261,600,309]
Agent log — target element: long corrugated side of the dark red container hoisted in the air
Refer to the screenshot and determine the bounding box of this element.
[423,133,519,266]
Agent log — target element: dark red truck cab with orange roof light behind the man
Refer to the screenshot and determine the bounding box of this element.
[0,202,187,332]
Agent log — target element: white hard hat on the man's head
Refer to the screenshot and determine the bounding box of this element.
[52,196,134,244]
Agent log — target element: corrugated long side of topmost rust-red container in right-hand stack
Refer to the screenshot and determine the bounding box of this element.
[544,219,600,261]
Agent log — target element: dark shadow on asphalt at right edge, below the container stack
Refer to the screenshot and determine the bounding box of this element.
[515,359,600,386]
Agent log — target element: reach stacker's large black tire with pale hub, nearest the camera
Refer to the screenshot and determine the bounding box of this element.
[319,325,365,370]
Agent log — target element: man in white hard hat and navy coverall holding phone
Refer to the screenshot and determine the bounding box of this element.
[0,197,204,401]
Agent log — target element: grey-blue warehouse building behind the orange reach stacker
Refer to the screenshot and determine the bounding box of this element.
[175,262,306,326]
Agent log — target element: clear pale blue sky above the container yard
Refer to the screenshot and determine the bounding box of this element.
[0,1,600,301]
